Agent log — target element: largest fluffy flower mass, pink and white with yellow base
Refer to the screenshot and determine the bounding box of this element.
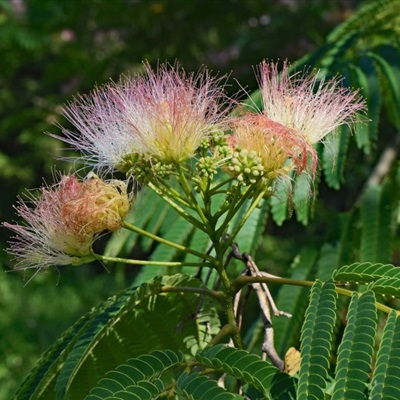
[61,63,228,170]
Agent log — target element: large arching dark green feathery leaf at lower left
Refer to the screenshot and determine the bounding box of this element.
[25,275,211,399]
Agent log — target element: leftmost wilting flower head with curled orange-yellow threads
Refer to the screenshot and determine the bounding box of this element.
[4,176,129,269]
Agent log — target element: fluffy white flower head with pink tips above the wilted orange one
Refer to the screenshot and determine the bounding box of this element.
[259,61,365,144]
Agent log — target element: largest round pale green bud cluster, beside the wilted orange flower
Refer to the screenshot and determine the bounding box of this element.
[228,149,264,185]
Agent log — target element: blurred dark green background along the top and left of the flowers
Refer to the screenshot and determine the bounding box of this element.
[0,0,365,400]
